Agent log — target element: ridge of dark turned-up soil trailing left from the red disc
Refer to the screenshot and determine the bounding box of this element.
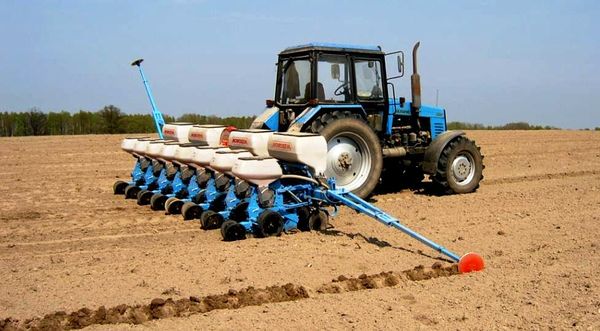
[0,262,458,331]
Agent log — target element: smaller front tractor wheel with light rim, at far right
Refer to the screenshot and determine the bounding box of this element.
[432,136,484,194]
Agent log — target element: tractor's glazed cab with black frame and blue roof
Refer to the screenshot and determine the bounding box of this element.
[273,43,389,131]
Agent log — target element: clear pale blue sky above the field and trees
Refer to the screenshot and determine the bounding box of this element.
[0,0,600,128]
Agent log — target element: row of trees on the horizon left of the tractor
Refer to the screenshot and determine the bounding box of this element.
[0,105,254,137]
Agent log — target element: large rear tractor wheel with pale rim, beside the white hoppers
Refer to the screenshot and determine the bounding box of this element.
[317,117,383,198]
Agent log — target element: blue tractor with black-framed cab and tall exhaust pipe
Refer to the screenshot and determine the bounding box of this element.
[251,43,484,198]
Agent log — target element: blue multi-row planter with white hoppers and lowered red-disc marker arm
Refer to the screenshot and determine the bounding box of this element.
[114,123,483,272]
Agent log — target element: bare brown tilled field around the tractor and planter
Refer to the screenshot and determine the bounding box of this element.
[0,131,600,330]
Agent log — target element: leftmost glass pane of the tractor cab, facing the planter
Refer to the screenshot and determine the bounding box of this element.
[278,59,310,105]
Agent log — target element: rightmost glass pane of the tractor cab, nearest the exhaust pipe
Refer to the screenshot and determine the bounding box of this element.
[354,60,383,101]
